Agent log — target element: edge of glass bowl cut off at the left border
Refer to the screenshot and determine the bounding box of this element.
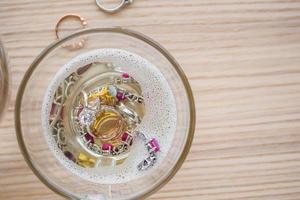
[0,40,9,120]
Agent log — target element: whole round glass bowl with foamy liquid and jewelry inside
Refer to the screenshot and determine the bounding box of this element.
[15,28,195,200]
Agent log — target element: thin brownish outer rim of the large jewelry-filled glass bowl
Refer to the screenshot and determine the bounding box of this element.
[15,27,196,199]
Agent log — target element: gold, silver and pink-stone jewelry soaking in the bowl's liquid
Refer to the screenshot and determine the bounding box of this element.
[49,62,160,171]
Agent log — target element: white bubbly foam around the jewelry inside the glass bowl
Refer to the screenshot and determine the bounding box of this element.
[42,49,177,184]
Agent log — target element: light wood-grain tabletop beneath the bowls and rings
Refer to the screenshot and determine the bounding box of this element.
[0,0,300,200]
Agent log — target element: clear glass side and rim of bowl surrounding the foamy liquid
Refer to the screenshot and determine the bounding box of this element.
[15,28,195,200]
